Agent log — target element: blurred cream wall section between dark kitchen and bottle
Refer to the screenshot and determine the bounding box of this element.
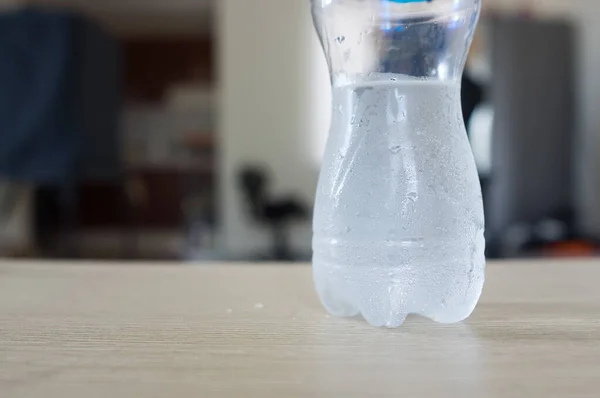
[217,0,329,256]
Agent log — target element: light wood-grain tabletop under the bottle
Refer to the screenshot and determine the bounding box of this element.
[0,261,600,398]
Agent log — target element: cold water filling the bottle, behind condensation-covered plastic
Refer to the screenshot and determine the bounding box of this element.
[313,74,485,327]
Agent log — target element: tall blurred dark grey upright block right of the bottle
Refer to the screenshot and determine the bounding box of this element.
[484,16,578,257]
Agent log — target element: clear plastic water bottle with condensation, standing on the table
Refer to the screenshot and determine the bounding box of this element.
[312,0,485,327]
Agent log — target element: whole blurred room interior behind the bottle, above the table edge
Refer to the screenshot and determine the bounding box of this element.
[0,0,600,261]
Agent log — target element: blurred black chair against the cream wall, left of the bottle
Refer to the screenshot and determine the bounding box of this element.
[239,166,309,261]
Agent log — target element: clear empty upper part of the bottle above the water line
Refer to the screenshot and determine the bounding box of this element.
[313,2,479,84]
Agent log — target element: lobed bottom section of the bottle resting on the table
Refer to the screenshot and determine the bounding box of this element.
[313,260,484,328]
